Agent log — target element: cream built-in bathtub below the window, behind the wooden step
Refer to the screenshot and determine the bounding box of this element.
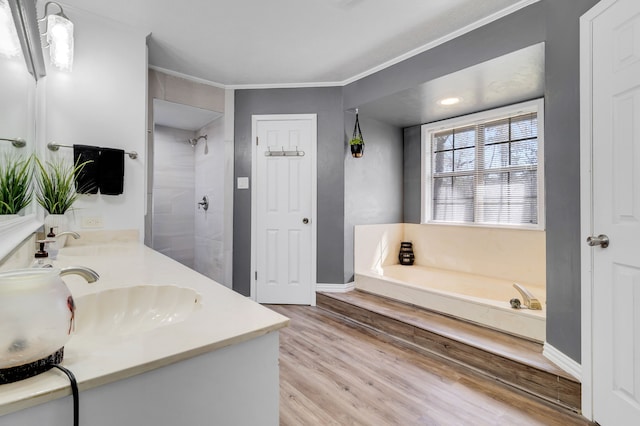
[355,265,546,342]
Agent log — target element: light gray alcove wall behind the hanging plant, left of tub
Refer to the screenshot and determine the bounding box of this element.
[344,113,403,282]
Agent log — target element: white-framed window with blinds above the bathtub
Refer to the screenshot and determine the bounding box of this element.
[423,101,544,228]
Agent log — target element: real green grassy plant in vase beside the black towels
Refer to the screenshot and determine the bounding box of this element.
[36,157,91,214]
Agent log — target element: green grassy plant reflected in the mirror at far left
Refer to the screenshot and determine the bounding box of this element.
[0,154,33,214]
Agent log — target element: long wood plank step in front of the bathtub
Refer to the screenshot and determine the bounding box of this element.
[317,290,581,412]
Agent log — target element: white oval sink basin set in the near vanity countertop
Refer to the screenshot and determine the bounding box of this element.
[75,285,202,336]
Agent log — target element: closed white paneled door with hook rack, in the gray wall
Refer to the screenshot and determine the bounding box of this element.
[252,115,317,305]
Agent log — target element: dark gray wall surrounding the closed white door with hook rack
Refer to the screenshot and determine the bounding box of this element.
[233,87,345,295]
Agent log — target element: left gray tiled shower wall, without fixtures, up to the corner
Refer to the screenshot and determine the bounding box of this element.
[152,126,195,268]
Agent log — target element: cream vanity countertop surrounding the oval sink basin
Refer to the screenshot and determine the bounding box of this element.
[0,236,289,415]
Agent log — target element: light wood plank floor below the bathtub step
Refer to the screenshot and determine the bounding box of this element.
[269,305,590,426]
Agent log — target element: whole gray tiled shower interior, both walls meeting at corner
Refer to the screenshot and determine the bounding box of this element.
[152,118,233,285]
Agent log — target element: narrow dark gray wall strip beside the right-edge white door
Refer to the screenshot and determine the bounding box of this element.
[544,0,598,362]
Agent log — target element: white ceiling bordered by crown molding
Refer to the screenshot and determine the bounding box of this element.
[63,0,536,86]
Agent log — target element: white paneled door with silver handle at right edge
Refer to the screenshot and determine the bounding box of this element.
[585,0,640,426]
